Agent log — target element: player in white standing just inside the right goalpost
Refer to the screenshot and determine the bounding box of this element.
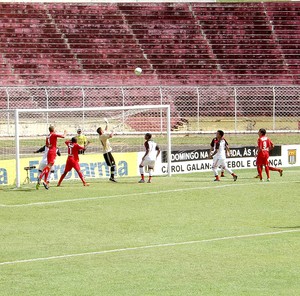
[139,133,160,183]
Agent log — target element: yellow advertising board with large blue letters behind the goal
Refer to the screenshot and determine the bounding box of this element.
[0,152,138,185]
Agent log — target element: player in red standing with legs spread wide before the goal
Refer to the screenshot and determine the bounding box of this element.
[57,137,89,186]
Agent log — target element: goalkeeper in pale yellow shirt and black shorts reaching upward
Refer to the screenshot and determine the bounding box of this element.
[97,120,117,182]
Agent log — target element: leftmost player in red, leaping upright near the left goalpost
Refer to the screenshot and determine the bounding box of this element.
[36,126,67,189]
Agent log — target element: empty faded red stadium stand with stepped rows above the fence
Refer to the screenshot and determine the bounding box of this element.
[0,2,300,86]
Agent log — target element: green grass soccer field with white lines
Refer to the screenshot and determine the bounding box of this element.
[0,168,300,296]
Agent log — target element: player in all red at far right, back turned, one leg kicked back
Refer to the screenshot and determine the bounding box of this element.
[256,128,283,181]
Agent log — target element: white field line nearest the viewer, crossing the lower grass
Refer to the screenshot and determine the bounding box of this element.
[0,229,300,266]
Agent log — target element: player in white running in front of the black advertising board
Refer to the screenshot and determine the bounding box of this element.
[210,130,237,181]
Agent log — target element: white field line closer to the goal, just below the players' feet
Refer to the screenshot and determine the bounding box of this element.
[0,181,299,208]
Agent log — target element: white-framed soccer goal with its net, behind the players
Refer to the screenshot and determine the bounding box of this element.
[0,105,171,187]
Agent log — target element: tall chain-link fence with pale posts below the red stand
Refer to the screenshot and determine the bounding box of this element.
[0,86,300,135]
